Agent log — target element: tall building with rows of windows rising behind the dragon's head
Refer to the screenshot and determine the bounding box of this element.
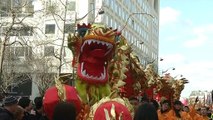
[76,0,160,72]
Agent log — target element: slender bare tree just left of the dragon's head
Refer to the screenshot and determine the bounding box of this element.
[42,0,76,74]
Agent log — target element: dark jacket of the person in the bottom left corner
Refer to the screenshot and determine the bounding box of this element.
[0,107,14,120]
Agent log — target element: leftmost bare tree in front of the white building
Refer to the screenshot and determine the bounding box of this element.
[0,1,35,93]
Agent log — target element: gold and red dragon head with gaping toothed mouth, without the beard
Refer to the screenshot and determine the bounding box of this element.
[68,24,120,84]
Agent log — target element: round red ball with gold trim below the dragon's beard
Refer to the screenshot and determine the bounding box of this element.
[87,97,133,120]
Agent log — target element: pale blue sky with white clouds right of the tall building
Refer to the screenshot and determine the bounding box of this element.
[159,0,213,97]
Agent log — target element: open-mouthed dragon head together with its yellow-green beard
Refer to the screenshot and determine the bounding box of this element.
[68,24,118,105]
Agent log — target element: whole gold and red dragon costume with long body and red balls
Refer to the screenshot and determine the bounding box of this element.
[44,24,188,120]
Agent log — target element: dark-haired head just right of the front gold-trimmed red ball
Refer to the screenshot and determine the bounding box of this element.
[134,103,158,120]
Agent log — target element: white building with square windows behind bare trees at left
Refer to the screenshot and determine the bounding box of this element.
[0,0,76,97]
